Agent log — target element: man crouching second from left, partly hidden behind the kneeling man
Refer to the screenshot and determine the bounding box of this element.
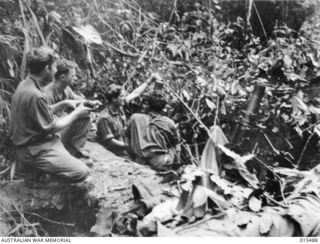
[44,59,102,158]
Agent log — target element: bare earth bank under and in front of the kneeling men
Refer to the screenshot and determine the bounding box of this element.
[0,142,165,236]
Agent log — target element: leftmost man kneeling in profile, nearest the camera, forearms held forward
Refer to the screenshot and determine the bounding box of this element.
[10,47,90,182]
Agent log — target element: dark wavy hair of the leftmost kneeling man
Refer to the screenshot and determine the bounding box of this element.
[27,46,59,75]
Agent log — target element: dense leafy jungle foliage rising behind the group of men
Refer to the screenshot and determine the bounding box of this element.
[0,0,320,178]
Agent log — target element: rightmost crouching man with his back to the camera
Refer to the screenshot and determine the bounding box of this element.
[127,94,180,171]
